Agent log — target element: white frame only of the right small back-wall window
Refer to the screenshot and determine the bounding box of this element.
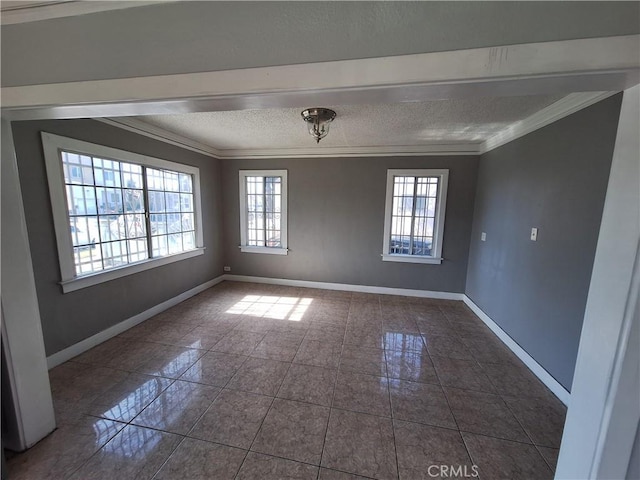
[382,169,449,265]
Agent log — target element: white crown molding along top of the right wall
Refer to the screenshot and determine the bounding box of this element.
[478,92,617,154]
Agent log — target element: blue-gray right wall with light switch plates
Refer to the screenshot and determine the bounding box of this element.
[466,95,621,390]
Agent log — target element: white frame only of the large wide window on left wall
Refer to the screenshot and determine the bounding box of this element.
[41,132,204,293]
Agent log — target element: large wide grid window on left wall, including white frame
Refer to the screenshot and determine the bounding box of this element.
[42,133,202,291]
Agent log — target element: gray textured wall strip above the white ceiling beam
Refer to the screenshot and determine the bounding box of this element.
[1,2,640,86]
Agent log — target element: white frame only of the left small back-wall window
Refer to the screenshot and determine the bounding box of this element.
[238,170,289,255]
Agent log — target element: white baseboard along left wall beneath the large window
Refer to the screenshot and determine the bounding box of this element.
[47,275,224,370]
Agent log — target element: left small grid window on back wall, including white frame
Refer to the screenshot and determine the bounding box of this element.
[240,170,287,255]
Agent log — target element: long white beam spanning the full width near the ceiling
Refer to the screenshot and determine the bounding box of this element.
[1,35,640,120]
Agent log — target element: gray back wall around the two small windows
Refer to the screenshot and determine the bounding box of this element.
[223,156,478,292]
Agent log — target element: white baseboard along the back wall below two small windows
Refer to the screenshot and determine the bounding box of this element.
[223,274,464,300]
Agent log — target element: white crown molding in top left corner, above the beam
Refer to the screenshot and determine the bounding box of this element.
[0,0,173,25]
